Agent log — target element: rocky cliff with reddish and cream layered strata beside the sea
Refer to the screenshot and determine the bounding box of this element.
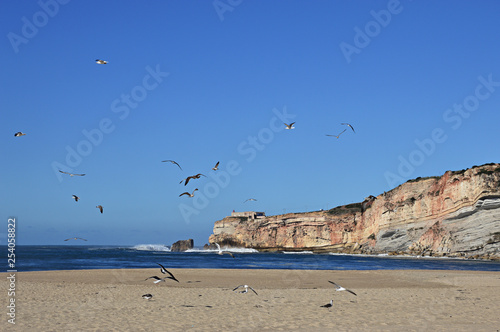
[209,164,500,259]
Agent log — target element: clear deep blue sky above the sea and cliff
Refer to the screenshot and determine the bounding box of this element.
[0,0,500,245]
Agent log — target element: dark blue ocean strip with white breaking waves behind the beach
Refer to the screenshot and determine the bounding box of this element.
[2,244,500,272]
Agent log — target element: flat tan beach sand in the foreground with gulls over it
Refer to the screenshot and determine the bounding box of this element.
[0,267,500,331]
